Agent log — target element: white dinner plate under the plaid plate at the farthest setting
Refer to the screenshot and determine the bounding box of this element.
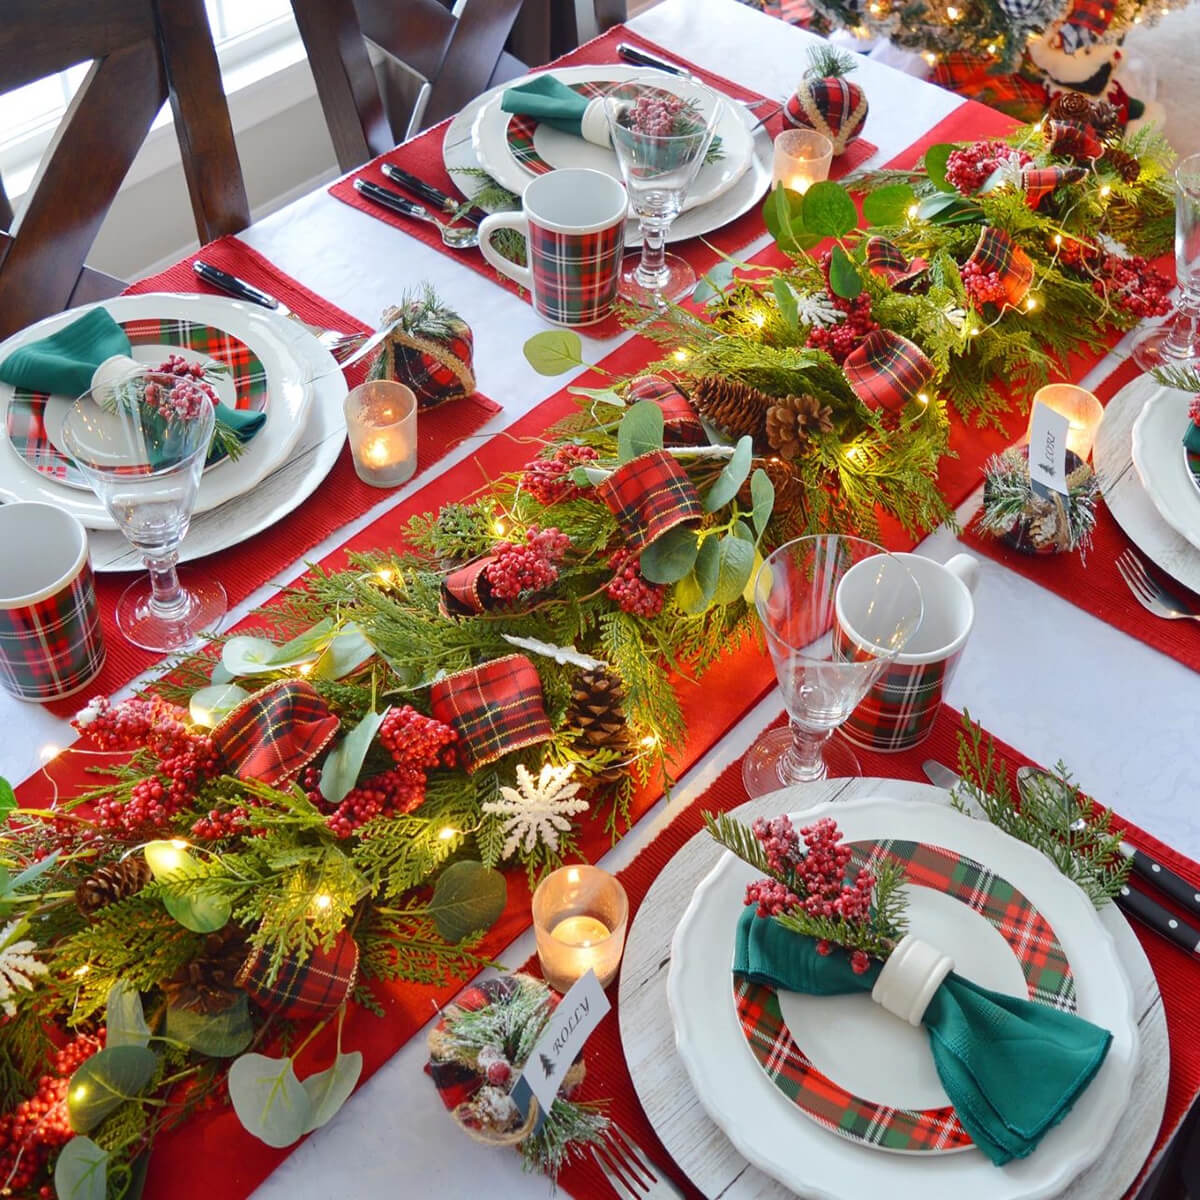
[470,65,754,211]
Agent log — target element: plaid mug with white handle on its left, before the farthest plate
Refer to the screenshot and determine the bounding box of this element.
[479,167,629,325]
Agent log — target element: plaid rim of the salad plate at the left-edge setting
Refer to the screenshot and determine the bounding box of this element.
[5,317,270,491]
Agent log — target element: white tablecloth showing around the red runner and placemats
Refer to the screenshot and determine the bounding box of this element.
[0,0,1200,1200]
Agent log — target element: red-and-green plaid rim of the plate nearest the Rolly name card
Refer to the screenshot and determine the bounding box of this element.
[733,841,1076,1153]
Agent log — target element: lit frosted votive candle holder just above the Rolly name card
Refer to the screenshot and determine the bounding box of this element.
[533,866,629,991]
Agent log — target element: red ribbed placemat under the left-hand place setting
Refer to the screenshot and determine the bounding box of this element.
[47,238,500,716]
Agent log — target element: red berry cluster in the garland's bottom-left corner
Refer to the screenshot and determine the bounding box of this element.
[0,1031,103,1196]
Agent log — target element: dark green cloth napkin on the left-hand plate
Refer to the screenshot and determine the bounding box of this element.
[0,308,266,442]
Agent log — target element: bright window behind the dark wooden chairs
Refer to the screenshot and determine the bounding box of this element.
[0,0,302,199]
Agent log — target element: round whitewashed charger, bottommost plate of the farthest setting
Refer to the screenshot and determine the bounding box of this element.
[442,67,774,250]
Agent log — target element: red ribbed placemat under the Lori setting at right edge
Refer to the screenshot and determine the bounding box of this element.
[962,360,1200,671]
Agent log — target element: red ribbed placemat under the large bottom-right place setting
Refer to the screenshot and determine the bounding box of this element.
[547,706,1200,1200]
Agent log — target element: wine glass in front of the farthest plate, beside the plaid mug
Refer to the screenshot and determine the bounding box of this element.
[605,73,725,307]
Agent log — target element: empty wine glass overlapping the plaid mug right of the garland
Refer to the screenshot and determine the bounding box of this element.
[742,534,924,797]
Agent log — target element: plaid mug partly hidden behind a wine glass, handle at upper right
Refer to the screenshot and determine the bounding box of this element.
[834,554,979,752]
